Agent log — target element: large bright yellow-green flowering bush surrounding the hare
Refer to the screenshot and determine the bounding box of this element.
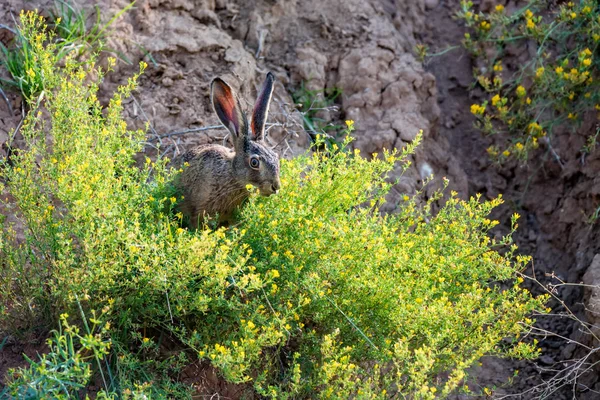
[0,10,544,399]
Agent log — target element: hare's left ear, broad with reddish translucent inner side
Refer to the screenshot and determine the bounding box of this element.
[210,78,248,148]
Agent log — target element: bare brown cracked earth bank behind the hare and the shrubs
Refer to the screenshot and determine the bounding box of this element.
[0,0,600,399]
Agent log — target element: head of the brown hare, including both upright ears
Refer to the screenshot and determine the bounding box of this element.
[211,72,281,196]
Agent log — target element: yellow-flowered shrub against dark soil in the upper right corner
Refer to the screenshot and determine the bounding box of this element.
[457,0,600,161]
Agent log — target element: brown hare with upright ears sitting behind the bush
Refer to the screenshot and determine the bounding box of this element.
[177,72,281,228]
